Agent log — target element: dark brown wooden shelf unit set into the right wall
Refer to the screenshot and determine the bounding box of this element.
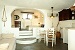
[59,9,75,21]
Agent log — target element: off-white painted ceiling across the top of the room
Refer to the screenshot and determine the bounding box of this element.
[1,0,75,10]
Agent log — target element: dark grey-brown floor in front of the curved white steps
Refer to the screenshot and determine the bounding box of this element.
[16,40,68,50]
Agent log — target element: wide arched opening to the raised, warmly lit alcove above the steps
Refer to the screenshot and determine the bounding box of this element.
[11,9,44,29]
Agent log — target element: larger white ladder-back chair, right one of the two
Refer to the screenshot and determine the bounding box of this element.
[46,28,56,47]
